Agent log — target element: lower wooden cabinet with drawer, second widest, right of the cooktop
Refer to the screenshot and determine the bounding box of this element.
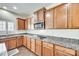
[43,42,54,56]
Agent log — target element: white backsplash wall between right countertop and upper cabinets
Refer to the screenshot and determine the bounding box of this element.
[27,29,79,39]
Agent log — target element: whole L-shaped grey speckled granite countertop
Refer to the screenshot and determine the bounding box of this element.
[0,33,79,50]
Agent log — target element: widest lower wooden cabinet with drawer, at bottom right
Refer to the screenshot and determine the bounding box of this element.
[55,45,75,56]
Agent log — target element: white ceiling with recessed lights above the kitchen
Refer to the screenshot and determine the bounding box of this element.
[0,3,52,17]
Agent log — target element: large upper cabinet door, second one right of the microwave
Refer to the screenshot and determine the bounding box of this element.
[54,4,67,29]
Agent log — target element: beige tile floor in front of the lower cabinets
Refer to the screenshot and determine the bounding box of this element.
[14,47,36,56]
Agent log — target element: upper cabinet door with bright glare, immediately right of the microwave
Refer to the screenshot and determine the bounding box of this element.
[45,9,54,29]
